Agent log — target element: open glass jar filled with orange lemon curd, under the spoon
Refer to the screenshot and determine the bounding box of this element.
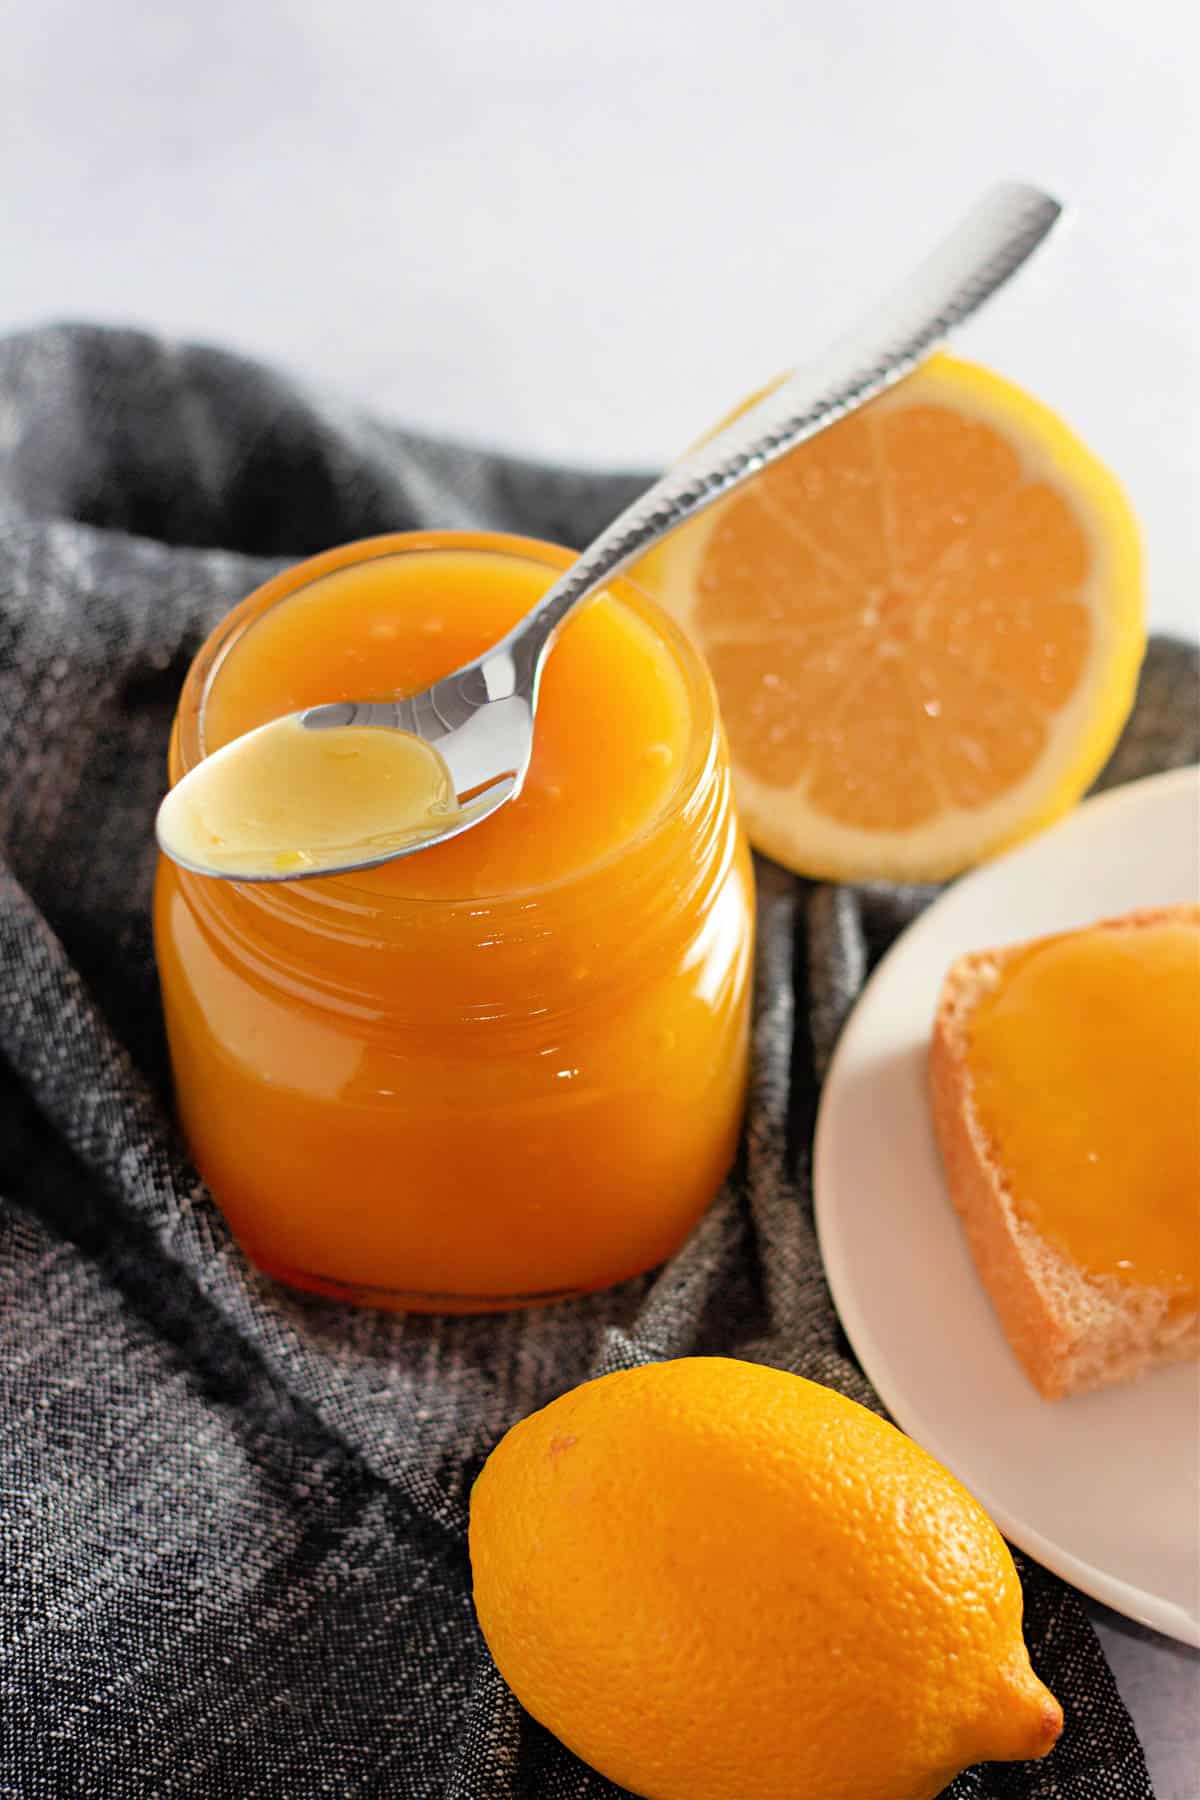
[155,533,752,1310]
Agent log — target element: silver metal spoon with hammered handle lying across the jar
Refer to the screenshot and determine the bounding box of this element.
[157,182,1061,880]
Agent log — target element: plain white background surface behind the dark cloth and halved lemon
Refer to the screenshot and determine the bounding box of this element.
[0,0,1200,1800]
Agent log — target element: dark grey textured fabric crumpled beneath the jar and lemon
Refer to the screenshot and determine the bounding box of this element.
[0,328,1196,1800]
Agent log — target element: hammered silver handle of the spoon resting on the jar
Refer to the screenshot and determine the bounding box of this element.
[480,182,1061,697]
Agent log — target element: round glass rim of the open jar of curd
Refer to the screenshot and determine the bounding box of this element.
[169,531,720,929]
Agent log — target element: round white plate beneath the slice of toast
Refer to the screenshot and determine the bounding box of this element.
[815,769,1200,1643]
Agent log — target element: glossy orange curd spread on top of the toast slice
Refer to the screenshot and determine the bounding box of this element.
[968,922,1200,1303]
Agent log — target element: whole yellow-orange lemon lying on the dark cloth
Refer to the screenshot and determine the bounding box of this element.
[470,1357,1061,1800]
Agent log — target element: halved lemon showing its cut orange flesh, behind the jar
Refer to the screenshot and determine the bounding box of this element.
[631,356,1146,880]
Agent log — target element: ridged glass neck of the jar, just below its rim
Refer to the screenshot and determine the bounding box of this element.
[176,722,738,1022]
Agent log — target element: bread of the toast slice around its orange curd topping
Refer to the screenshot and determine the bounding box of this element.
[928,905,1200,1400]
